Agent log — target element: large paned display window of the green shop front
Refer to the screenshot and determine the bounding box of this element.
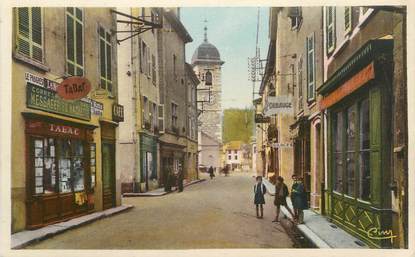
[332,98,372,201]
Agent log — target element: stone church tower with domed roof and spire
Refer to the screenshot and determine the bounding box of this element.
[192,27,224,168]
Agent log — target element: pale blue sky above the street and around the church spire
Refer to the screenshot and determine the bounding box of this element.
[180,7,269,109]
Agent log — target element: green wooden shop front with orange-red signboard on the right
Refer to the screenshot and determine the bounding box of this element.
[319,40,395,247]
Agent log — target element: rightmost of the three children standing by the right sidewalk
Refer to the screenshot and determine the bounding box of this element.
[291,175,308,224]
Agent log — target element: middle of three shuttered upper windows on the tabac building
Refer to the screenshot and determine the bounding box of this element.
[66,7,84,76]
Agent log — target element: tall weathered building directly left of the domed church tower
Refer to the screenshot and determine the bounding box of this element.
[157,8,195,188]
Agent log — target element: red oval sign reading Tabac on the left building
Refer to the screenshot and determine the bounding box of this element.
[57,76,91,100]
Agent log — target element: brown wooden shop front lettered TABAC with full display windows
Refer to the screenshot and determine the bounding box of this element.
[23,113,95,229]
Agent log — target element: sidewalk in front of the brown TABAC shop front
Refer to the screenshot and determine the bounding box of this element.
[11,205,133,249]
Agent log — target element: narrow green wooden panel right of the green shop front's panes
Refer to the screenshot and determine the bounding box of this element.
[370,88,382,205]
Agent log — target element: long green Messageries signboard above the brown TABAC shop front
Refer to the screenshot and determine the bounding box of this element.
[26,83,91,120]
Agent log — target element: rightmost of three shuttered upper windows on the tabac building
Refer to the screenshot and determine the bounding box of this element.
[99,26,112,92]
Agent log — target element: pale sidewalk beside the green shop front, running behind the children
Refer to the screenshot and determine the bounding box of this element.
[263,179,369,249]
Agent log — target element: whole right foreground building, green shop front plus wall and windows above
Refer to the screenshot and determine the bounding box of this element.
[318,6,407,247]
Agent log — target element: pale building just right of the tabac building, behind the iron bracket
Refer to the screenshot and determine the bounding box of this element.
[118,8,164,193]
